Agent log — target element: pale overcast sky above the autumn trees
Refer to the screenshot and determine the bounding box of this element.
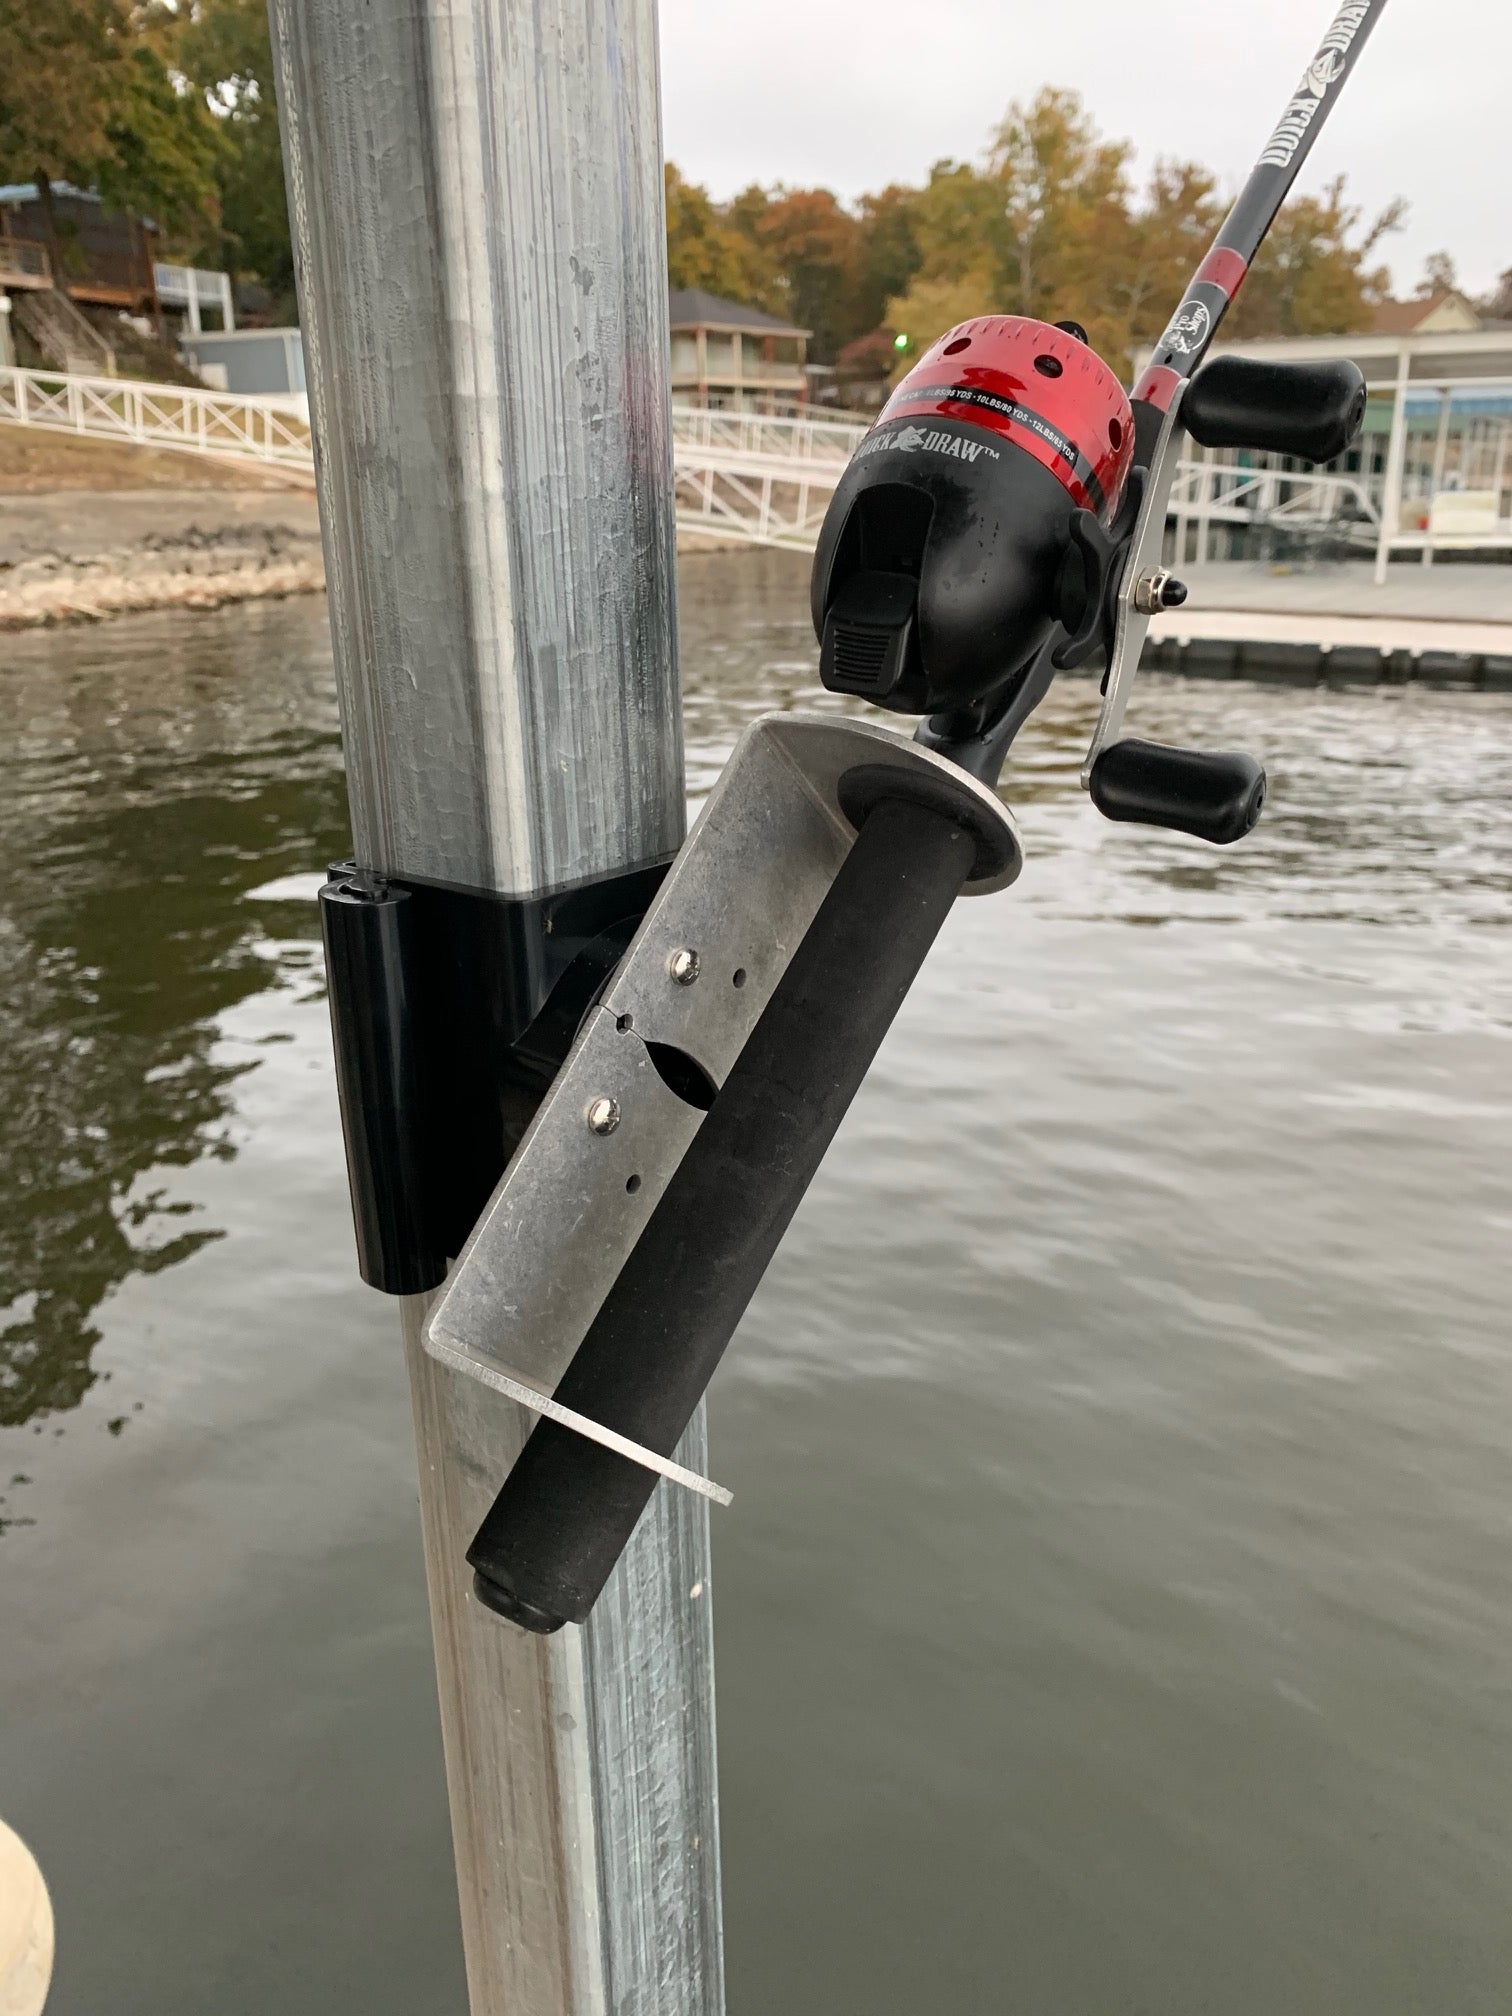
[659,0,1512,298]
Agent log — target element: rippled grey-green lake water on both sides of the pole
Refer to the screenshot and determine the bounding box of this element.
[0,556,1512,2016]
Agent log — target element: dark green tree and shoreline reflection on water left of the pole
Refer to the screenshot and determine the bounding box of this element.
[0,609,347,1427]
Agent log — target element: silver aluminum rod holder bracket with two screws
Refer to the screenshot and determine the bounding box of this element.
[425,714,1022,1504]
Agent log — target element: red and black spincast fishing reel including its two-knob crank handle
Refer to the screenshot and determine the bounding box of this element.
[812,314,1365,845]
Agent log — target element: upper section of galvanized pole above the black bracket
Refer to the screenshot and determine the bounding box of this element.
[272,0,683,895]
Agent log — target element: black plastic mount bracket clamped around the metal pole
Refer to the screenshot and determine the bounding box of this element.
[321,861,667,1294]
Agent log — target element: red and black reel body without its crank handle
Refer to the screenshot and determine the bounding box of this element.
[812,326,1133,737]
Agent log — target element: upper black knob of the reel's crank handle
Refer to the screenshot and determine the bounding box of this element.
[1181,357,1365,462]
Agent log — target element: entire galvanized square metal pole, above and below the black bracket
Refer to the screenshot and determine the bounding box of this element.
[270,0,724,2016]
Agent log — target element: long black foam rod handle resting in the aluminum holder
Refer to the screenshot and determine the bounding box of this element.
[468,798,976,1631]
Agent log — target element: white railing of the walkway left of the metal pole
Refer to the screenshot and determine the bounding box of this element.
[0,367,312,474]
